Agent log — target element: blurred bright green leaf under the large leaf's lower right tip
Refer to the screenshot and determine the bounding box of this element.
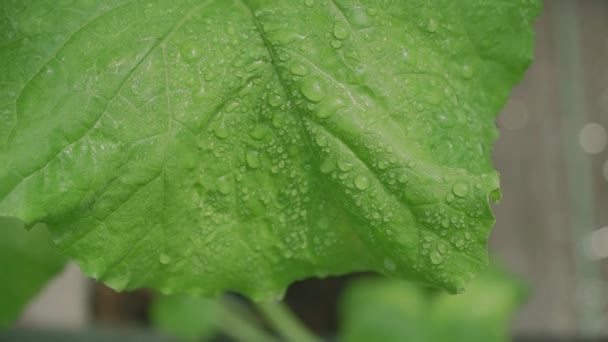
[340,270,525,342]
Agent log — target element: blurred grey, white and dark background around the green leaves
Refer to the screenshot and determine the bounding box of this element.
[0,0,608,339]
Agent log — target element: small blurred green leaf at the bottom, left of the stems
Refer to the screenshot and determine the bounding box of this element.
[150,295,219,340]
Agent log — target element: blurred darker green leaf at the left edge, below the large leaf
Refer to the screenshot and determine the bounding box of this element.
[0,217,65,329]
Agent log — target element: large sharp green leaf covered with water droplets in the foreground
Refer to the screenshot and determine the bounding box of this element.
[0,0,539,299]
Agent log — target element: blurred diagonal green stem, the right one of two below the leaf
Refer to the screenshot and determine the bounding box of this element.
[256,302,320,342]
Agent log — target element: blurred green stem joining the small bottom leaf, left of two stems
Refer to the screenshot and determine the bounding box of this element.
[216,303,278,342]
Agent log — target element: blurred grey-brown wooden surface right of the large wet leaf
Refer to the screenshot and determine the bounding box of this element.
[491,0,608,336]
